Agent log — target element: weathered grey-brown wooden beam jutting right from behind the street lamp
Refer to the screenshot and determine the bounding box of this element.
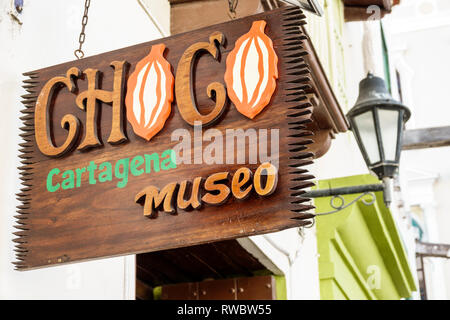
[402,126,450,150]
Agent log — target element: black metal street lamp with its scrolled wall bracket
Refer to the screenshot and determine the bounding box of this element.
[302,73,411,215]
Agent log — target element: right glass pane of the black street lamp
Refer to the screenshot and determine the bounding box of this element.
[378,109,400,161]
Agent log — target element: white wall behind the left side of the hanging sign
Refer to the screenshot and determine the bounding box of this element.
[0,0,169,299]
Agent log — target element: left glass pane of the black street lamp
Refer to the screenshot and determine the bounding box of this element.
[353,111,380,164]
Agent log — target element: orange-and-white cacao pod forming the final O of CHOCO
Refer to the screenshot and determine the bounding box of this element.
[225,20,278,119]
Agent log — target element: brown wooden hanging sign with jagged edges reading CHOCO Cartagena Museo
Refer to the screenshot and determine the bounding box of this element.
[14,7,312,269]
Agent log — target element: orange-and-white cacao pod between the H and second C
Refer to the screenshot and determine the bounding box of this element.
[125,44,174,141]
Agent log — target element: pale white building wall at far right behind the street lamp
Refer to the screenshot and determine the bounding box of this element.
[384,0,450,299]
